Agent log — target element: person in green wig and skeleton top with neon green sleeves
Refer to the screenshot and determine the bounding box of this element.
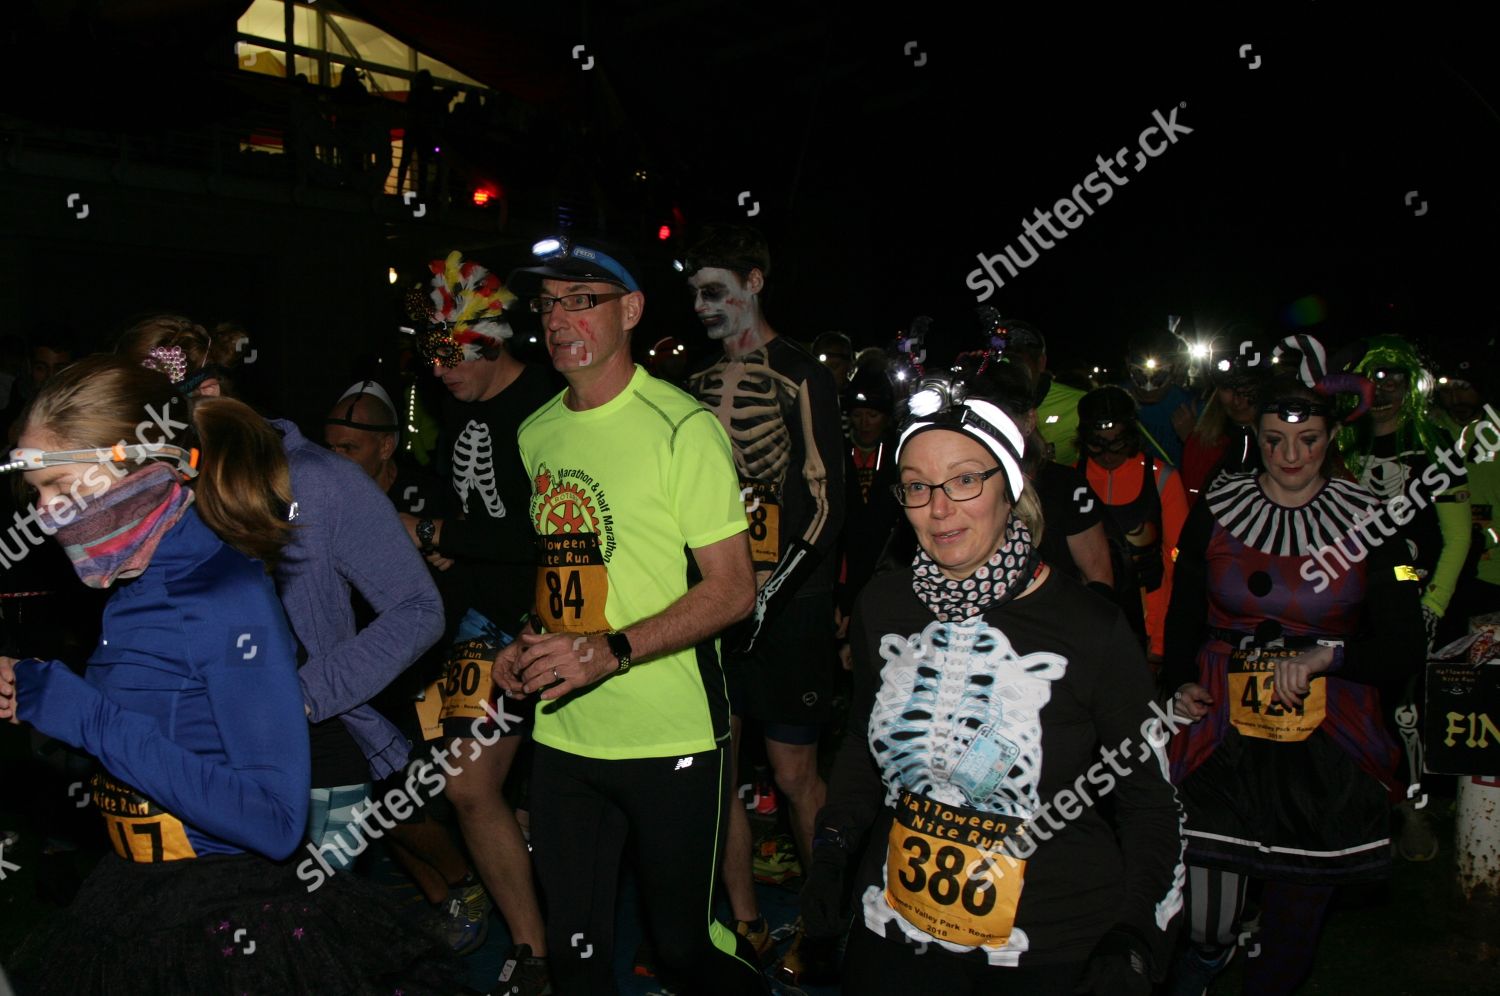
[1338,336,1470,861]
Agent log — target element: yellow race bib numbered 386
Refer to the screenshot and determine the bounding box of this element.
[885,792,1026,947]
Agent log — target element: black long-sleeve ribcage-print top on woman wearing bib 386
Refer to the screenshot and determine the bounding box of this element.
[819,572,1185,972]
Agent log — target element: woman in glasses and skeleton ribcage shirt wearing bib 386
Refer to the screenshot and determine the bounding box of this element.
[801,378,1182,996]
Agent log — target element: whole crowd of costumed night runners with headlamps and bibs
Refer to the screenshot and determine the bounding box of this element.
[0,227,1500,996]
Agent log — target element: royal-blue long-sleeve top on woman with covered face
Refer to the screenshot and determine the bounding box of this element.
[17,507,311,860]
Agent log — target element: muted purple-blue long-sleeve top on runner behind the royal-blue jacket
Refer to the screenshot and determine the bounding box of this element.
[272,419,443,780]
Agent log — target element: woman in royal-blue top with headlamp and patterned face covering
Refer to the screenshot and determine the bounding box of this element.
[0,357,450,995]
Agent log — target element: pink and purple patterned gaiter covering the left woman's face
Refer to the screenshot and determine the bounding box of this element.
[38,464,194,588]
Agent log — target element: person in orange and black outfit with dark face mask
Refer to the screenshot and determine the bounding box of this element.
[1079,387,1188,662]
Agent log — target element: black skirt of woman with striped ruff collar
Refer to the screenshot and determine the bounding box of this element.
[1178,728,1391,885]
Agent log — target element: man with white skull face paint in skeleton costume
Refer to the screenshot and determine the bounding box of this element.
[687,227,845,954]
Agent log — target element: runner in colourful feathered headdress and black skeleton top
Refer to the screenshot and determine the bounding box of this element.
[402,252,554,993]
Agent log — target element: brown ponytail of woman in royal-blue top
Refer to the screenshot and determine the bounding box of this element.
[192,398,291,567]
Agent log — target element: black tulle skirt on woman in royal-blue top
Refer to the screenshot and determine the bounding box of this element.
[11,851,464,996]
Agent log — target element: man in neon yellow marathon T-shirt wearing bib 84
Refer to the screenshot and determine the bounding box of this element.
[494,239,767,995]
